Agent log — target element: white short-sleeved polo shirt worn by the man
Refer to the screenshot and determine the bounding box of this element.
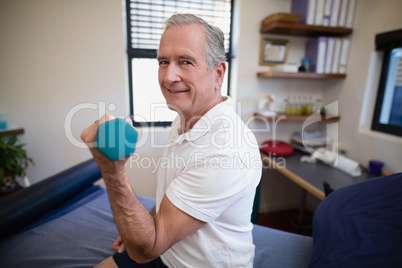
[156,97,262,267]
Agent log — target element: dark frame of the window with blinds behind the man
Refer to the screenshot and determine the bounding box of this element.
[125,0,234,127]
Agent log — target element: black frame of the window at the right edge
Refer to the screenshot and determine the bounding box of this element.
[371,29,402,137]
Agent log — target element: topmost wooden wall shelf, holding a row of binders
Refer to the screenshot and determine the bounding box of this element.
[260,22,353,37]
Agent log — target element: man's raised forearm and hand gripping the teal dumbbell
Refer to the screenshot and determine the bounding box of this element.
[81,115,166,262]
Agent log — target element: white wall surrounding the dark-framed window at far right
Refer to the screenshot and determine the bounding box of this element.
[324,0,402,172]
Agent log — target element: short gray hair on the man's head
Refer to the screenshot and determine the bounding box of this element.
[162,14,226,70]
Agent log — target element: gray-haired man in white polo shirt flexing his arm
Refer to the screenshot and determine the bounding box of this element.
[81,14,261,267]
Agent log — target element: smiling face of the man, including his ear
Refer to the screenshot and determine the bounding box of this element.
[158,24,226,120]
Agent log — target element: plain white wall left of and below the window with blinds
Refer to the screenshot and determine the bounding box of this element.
[0,0,168,196]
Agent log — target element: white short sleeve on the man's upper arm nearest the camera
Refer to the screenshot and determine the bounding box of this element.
[166,154,261,222]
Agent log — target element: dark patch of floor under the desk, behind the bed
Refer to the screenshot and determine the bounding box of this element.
[257,209,313,236]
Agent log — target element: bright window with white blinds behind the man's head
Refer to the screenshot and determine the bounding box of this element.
[126,0,233,126]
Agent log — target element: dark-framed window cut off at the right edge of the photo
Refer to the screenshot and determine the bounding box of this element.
[371,30,402,137]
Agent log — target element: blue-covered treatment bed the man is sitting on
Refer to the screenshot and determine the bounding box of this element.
[0,186,313,268]
